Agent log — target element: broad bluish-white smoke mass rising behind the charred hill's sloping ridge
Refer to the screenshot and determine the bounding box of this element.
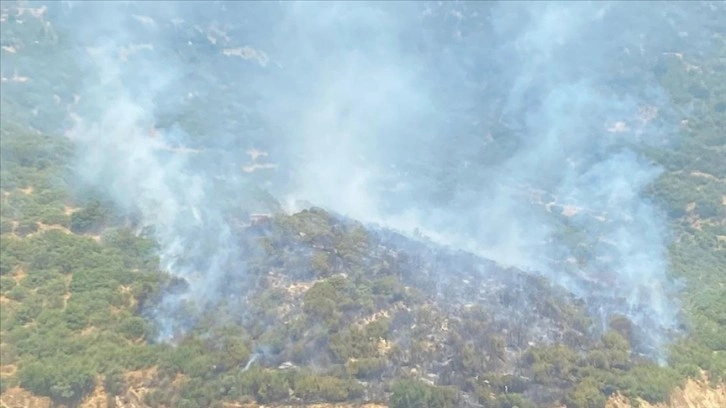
[270,3,692,356]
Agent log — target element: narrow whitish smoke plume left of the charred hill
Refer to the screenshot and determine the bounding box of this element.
[58,3,242,340]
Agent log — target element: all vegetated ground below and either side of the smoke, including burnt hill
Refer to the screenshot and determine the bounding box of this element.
[0,0,726,408]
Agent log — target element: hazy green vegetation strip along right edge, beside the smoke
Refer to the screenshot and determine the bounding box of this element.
[651,39,726,381]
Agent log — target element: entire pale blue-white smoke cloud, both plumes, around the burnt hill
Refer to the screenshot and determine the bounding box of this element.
[47,2,724,349]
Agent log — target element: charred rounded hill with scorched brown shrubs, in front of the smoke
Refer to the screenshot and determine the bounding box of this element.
[121,208,650,406]
